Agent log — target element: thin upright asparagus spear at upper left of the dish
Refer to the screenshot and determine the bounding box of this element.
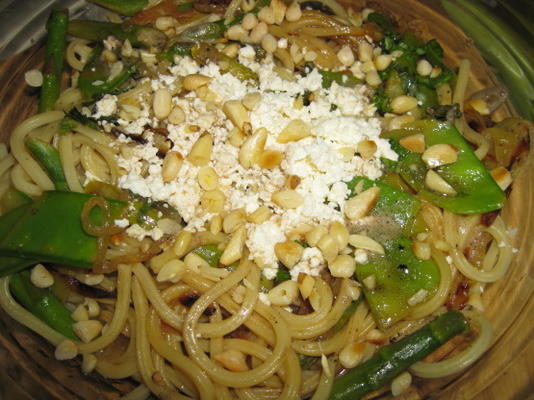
[39,8,69,112]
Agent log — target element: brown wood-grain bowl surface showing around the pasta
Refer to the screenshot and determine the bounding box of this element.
[0,0,534,400]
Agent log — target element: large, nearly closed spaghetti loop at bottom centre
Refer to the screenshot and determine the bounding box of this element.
[182,260,289,388]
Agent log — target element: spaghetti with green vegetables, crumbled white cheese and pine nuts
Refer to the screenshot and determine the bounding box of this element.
[0,0,531,399]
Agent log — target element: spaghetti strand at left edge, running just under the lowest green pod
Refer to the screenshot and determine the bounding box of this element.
[0,276,66,346]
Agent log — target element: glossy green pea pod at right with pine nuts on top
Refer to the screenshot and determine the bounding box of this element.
[382,120,505,214]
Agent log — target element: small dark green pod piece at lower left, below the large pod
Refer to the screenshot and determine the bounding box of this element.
[9,271,78,340]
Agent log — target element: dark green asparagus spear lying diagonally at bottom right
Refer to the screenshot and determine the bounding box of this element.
[328,310,469,400]
